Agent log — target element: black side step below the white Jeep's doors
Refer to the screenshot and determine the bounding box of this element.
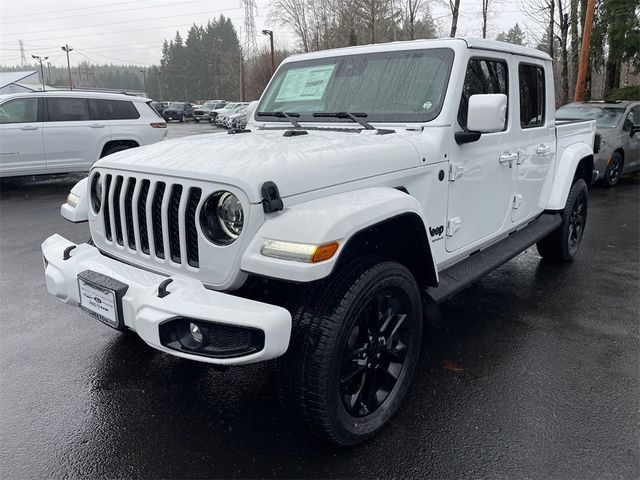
[424,213,562,303]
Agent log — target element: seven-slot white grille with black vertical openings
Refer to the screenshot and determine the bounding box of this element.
[101,174,202,268]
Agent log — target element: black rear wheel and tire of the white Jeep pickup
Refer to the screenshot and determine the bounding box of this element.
[536,179,589,262]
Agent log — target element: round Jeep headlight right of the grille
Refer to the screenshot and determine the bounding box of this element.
[200,192,244,245]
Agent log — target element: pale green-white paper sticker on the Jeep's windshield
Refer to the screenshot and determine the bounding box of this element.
[276,64,335,102]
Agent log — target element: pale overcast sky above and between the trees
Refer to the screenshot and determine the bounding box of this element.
[0,0,537,66]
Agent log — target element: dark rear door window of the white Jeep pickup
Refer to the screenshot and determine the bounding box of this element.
[518,63,545,128]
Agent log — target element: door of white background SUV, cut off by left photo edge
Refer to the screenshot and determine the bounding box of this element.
[0,96,46,177]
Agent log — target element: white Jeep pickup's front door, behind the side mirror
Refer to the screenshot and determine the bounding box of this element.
[445,53,517,252]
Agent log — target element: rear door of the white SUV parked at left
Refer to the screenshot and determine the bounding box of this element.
[44,97,111,172]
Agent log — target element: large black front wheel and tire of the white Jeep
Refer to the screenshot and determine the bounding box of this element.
[276,257,422,445]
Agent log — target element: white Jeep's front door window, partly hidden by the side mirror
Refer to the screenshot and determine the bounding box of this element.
[458,58,509,130]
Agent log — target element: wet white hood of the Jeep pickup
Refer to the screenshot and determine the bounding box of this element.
[95,130,420,203]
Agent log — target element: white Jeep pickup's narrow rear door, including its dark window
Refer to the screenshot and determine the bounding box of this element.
[511,56,556,223]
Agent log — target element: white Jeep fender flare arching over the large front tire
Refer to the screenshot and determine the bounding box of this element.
[241,187,436,282]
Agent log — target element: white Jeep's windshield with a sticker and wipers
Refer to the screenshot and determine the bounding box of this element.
[257,48,453,122]
